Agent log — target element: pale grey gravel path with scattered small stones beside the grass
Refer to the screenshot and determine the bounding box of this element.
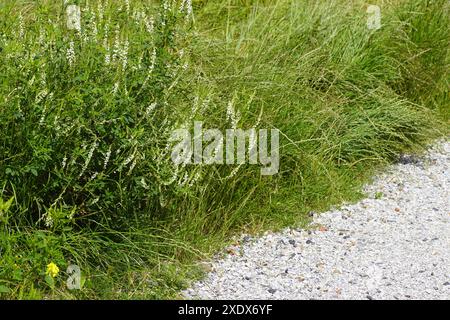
[183,141,450,299]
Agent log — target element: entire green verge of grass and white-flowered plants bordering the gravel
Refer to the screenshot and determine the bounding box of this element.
[0,0,450,298]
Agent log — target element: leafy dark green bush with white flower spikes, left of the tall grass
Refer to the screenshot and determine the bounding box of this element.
[0,1,200,229]
